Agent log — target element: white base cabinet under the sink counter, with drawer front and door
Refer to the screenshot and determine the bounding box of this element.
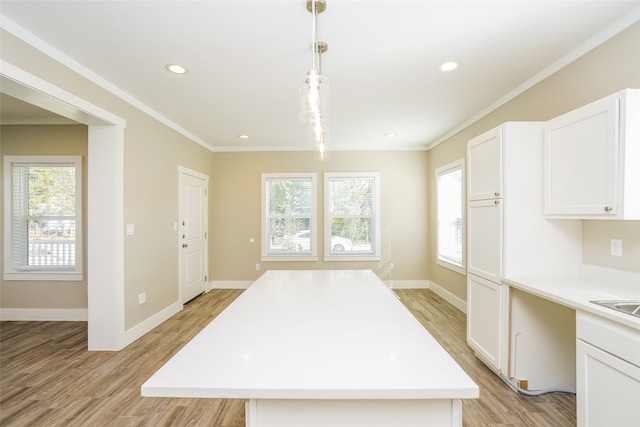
[576,312,640,427]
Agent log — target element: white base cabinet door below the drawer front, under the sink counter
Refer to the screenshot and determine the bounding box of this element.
[576,340,640,427]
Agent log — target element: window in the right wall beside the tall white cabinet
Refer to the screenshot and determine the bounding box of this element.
[436,159,466,274]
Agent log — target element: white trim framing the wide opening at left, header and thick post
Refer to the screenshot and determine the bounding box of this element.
[0,61,126,350]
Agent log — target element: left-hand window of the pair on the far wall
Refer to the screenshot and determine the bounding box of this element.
[262,174,317,261]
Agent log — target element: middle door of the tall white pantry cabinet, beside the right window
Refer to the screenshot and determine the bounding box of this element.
[467,199,503,282]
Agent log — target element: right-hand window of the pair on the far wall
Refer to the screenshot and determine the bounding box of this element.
[324,172,380,261]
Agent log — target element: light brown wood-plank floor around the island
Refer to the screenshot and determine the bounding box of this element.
[0,289,576,427]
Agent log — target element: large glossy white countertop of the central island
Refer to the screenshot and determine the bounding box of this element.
[142,270,479,399]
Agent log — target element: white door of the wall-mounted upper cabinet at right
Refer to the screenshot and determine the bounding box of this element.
[544,97,620,216]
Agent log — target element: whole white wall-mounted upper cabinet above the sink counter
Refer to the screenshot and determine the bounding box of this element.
[544,89,640,219]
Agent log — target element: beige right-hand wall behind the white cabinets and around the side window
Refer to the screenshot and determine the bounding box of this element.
[429,20,640,300]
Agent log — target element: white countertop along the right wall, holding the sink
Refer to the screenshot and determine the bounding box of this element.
[503,268,640,330]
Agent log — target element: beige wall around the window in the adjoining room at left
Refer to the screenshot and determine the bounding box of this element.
[0,125,87,309]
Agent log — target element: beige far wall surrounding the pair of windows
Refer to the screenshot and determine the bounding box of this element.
[210,151,429,281]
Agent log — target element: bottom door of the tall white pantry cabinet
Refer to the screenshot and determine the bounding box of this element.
[467,274,503,371]
